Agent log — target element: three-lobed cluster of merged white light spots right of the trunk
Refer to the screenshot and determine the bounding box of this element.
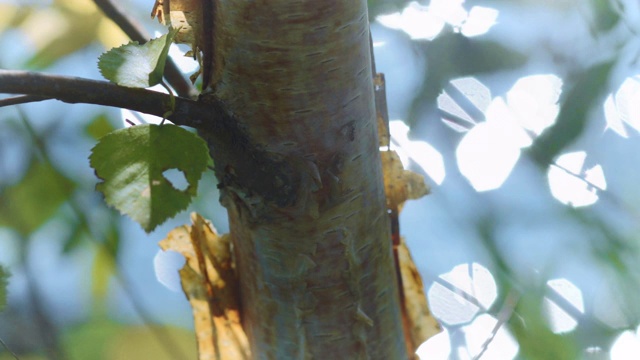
[437,75,562,191]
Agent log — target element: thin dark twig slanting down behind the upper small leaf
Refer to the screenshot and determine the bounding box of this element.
[93,0,198,98]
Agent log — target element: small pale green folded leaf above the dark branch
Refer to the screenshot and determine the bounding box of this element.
[98,28,178,88]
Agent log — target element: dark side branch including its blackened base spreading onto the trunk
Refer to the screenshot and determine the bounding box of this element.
[0,69,299,204]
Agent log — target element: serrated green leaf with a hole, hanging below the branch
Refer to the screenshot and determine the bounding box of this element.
[90,125,209,232]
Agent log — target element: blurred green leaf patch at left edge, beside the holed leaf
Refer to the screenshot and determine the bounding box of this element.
[0,161,75,235]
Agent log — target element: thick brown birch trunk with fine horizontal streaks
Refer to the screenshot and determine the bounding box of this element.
[198,0,407,359]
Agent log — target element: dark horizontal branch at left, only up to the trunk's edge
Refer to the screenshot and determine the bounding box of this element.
[0,69,209,128]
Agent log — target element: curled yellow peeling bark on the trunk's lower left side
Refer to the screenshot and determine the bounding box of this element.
[160,213,251,360]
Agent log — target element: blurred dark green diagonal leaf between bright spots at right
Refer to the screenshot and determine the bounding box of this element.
[530,62,613,168]
